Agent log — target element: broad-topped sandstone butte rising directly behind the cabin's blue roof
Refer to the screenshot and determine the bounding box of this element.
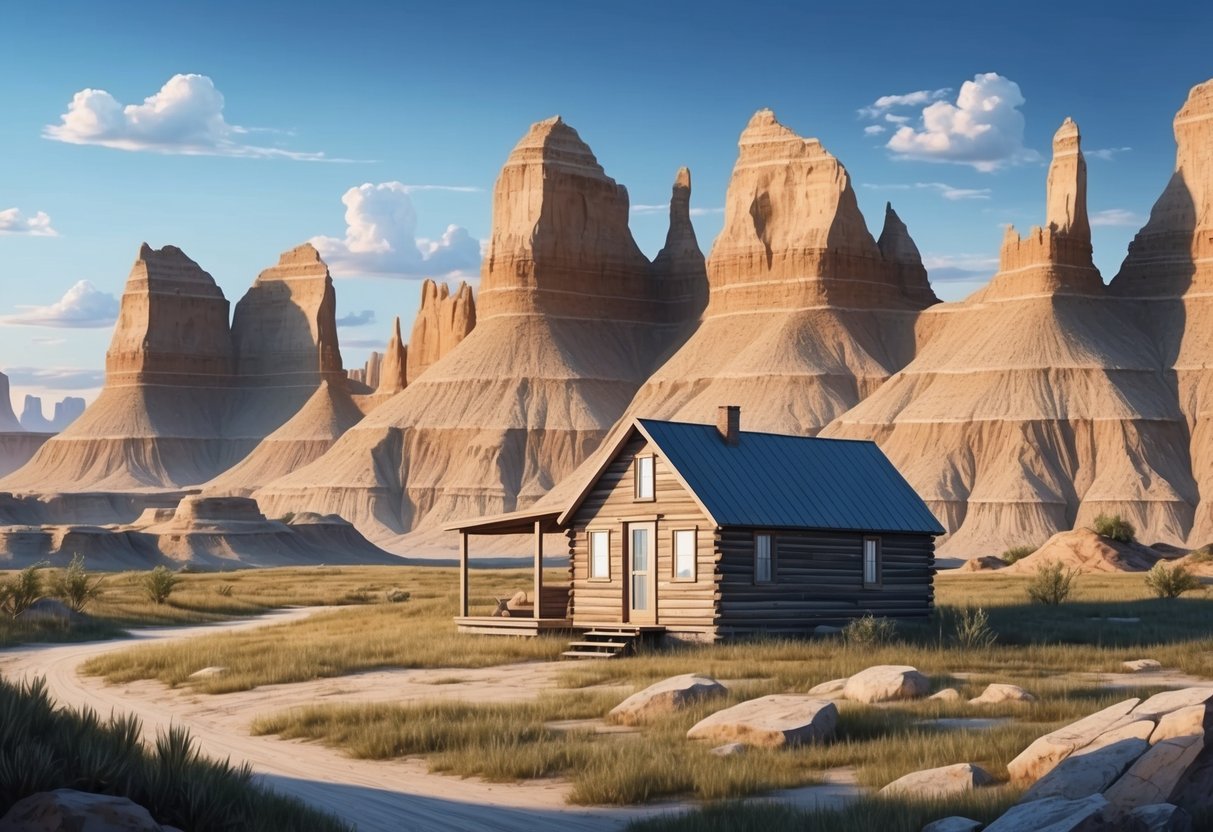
[611,110,936,434]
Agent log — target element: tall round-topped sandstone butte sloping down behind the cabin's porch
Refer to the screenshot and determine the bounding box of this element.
[256,116,702,542]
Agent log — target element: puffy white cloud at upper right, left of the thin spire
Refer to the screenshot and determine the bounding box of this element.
[885,73,1041,172]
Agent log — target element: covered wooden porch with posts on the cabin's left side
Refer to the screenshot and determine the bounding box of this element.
[446,512,573,636]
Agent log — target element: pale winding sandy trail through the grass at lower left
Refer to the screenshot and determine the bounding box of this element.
[0,608,854,832]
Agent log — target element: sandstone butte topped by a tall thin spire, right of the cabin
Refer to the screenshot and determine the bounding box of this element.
[824,119,1195,557]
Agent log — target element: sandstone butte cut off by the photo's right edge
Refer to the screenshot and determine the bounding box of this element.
[1111,80,1213,546]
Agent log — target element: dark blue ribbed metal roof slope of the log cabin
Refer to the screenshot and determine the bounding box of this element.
[637,418,944,535]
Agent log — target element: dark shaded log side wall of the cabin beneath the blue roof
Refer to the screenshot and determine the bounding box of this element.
[717,528,935,636]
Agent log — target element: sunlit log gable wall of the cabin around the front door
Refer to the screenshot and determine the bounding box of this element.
[569,435,719,633]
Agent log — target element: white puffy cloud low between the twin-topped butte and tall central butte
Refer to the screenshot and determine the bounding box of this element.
[312,182,480,278]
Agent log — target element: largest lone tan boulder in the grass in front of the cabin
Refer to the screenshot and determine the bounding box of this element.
[687,694,838,748]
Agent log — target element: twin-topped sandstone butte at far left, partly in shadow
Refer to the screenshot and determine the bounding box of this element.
[0,244,344,492]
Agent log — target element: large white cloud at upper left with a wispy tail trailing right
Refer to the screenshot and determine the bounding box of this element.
[42,74,337,161]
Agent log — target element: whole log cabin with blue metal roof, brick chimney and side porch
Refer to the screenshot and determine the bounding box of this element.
[449,406,944,655]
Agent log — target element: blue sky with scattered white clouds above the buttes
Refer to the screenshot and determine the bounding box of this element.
[0,0,1213,412]
